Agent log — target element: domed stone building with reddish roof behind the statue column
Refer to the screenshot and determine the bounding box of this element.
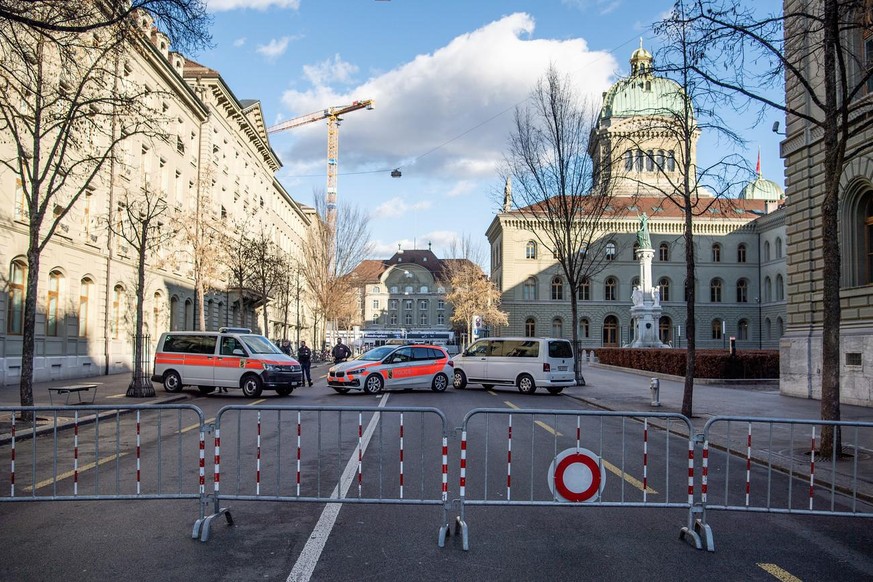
[486,49,786,349]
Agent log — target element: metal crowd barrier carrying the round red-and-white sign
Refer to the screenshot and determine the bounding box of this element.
[456,408,702,550]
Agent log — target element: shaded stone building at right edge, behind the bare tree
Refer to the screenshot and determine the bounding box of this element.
[780,0,873,406]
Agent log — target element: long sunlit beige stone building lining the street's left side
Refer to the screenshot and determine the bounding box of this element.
[0,12,313,385]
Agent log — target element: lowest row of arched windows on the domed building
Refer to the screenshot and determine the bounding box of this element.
[524,315,785,346]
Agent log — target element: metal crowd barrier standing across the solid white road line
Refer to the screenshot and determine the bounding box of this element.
[192,405,450,547]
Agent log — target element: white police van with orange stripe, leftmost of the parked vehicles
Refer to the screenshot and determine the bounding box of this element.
[152,327,303,398]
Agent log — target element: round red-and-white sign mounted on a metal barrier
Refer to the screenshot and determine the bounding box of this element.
[548,448,606,503]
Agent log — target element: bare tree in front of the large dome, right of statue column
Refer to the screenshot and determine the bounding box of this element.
[613,16,751,418]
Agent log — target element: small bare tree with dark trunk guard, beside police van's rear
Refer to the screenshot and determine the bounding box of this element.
[109,188,176,398]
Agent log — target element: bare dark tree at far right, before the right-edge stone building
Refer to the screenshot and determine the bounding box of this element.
[660,0,873,455]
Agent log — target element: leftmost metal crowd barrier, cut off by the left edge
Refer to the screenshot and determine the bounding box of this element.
[0,404,205,518]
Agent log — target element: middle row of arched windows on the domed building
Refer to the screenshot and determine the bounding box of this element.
[522,274,785,303]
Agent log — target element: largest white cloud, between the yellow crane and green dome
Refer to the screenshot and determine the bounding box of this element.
[278,13,618,181]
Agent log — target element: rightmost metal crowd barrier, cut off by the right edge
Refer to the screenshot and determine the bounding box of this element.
[695,416,873,551]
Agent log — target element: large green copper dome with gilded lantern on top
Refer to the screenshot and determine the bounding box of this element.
[600,42,684,119]
